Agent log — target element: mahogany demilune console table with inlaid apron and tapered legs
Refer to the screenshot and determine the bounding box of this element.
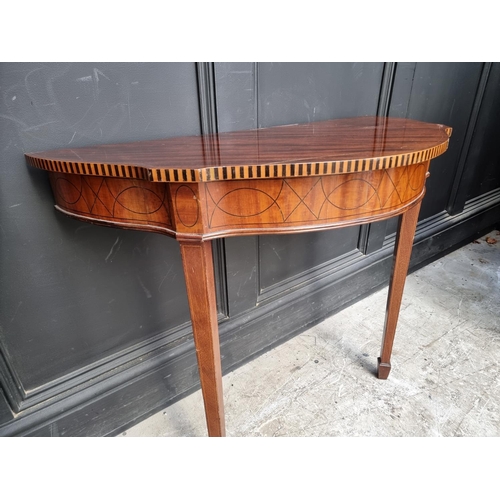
[26,117,451,436]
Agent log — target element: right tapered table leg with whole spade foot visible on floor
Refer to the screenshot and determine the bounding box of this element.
[378,202,421,379]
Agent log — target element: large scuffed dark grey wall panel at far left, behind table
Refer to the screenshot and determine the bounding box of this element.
[0,63,200,410]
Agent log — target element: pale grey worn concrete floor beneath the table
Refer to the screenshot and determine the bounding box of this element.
[121,231,500,437]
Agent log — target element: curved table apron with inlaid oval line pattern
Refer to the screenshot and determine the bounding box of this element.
[49,161,429,240]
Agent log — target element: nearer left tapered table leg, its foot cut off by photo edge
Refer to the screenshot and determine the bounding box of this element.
[179,241,226,436]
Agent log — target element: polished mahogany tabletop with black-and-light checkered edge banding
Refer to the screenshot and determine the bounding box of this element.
[26,117,451,182]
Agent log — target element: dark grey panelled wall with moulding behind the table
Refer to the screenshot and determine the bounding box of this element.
[0,63,500,436]
